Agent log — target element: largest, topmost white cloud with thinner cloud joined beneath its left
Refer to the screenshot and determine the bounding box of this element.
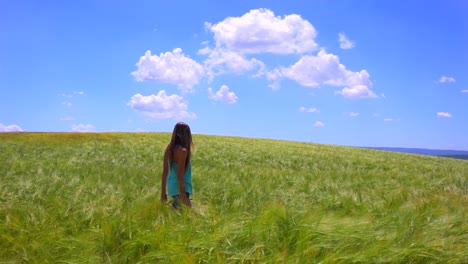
[198,9,317,81]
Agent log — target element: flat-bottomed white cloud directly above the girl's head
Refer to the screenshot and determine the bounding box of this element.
[128,90,196,119]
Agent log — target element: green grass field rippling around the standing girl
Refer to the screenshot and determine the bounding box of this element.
[0,133,468,263]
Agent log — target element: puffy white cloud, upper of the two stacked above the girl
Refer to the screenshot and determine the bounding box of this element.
[132,48,204,92]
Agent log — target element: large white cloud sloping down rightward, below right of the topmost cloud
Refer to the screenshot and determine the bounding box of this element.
[278,50,378,98]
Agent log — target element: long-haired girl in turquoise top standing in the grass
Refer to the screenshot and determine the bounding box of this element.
[161,122,193,209]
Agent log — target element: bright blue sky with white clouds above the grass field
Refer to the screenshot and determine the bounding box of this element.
[0,0,468,150]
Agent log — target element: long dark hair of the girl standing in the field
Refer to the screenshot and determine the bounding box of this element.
[166,122,193,170]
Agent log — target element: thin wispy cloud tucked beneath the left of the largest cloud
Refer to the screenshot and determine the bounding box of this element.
[198,47,265,82]
